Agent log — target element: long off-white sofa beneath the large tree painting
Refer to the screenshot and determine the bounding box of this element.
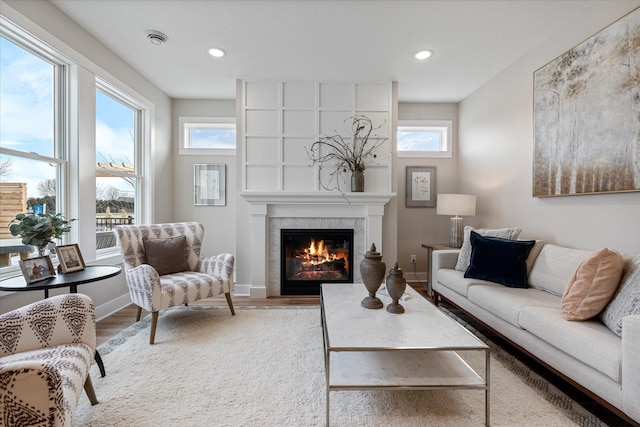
[431,244,640,423]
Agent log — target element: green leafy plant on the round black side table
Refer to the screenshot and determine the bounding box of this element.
[9,213,75,256]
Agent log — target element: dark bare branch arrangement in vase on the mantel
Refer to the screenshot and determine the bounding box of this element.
[307,115,387,191]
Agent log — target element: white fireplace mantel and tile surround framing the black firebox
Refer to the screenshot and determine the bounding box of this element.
[240,192,395,298]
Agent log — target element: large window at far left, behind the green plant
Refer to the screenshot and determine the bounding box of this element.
[0,19,69,268]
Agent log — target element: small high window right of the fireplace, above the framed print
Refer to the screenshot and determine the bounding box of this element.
[398,120,453,157]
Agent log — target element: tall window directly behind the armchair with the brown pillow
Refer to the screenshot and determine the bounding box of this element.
[96,79,143,250]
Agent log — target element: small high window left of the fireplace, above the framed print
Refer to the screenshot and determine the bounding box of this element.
[178,117,236,155]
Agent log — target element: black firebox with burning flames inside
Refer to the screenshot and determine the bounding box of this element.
[280,229,353,295]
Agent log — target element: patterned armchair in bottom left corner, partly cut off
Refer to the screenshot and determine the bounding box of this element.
[0,294,98,427]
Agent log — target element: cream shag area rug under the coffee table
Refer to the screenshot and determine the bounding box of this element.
[73,307,599,427]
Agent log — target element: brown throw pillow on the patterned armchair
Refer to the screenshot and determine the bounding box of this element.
[142,236,189,276]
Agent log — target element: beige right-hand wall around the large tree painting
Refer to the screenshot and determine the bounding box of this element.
[458,1,640,254]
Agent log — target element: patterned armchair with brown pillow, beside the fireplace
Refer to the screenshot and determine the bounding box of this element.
[115,222,235,344]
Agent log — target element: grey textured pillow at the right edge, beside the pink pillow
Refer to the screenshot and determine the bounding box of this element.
[602,255,640,336]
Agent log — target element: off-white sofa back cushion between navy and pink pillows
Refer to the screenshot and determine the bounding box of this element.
[529,243,593,297]
